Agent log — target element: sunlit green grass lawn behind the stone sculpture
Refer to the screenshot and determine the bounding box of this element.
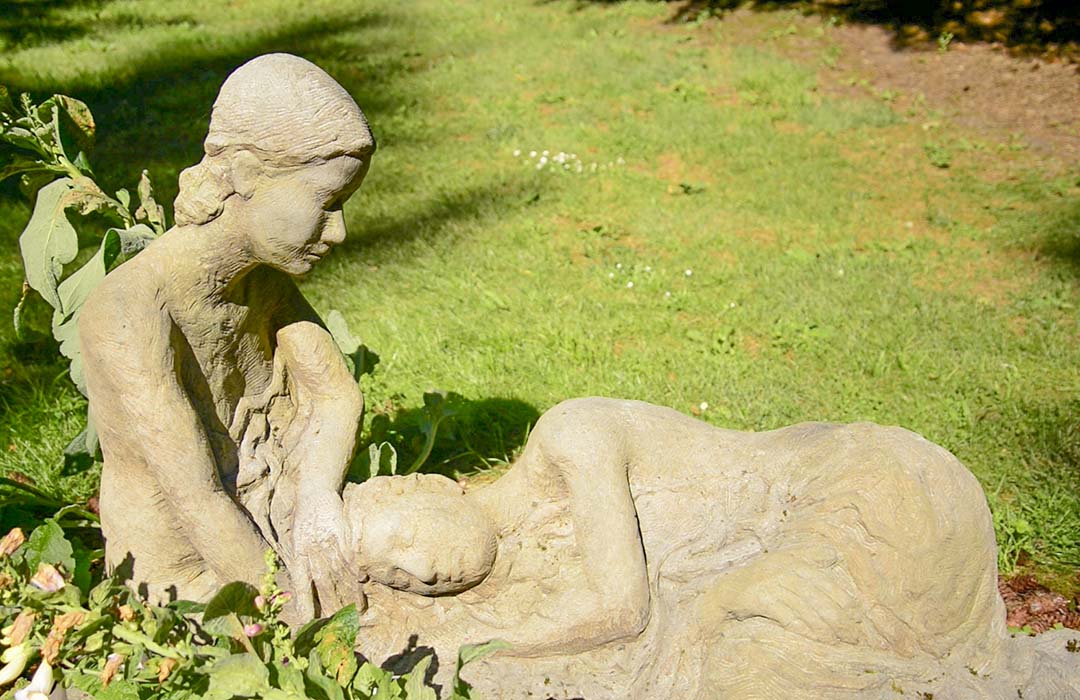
[0,0,1080,587]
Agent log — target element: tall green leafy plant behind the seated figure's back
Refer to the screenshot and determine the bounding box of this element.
[0,86,166,462]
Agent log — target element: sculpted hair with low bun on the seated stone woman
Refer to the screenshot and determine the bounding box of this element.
[174,54,375,226]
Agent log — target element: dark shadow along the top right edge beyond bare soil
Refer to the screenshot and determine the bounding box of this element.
[579,0,1080,53]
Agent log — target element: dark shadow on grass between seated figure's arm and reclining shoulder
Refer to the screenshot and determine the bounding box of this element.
[357,392,540,479]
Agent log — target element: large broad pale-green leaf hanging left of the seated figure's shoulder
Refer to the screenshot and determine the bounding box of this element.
[18,177,79,309]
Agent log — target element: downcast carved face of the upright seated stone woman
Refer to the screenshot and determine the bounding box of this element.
[243,156,370,274]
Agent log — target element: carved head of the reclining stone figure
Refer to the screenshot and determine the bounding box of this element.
[343,474,498,595]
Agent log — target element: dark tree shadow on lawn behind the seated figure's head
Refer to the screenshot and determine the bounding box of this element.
[0,6,411,212]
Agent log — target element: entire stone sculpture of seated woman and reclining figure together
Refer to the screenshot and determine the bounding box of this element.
[81,54,1080,700]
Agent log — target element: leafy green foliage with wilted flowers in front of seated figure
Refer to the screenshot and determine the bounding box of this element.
[0,514,494,700]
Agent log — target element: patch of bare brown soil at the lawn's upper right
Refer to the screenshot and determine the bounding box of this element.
[829,24,1080,166]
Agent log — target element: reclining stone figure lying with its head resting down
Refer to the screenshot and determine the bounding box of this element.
[345,399,1080,700]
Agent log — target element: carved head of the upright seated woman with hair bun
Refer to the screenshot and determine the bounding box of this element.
[175,54,375,273]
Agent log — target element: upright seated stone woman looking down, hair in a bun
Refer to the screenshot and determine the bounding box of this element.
[80,54,375,616]
